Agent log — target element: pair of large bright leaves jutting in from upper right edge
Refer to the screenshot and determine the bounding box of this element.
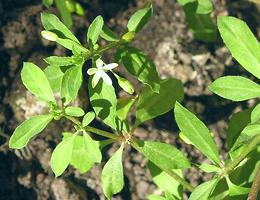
[210,17,260,101]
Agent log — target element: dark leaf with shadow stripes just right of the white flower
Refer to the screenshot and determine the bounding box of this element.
[116,47,160,93]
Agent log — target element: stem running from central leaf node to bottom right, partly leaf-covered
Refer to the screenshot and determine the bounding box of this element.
[131,140,194,192]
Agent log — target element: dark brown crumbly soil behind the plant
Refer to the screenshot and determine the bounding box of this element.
[0,0,260,200]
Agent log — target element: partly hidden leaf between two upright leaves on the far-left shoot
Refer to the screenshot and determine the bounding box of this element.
[44,65,64,92]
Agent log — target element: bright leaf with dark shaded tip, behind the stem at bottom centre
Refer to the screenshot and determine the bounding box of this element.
[148,162,182,199]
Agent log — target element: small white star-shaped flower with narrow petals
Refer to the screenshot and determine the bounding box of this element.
[87,59,118,88]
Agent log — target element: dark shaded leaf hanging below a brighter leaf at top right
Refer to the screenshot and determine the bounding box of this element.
[183,1,217,42]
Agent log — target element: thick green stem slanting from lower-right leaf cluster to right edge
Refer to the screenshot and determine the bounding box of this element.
[222,134,260,176]
